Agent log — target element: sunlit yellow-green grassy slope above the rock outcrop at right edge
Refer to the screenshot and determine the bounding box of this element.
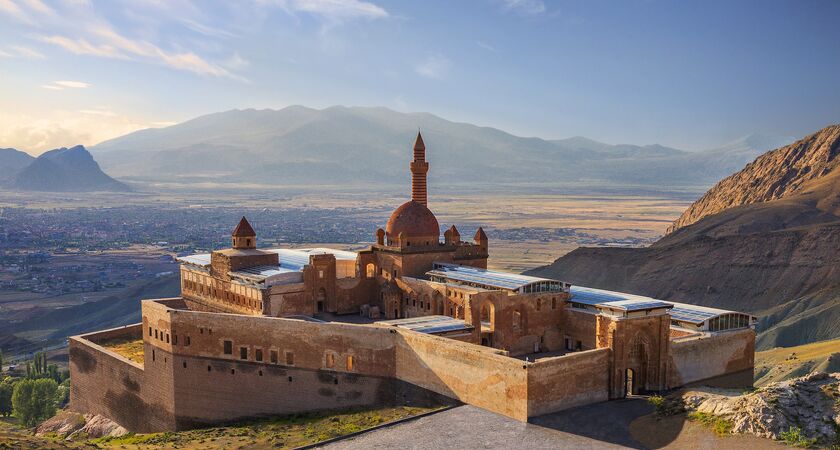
[755,339,840,386]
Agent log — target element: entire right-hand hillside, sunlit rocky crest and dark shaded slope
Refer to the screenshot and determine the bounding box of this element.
[531,125,840,348]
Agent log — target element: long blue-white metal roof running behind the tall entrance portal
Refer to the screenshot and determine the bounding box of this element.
[569,286,749,324]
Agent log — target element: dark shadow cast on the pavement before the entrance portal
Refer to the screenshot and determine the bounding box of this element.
[528,398,684,449]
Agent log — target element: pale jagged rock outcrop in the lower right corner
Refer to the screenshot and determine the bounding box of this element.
[682,372,840,445]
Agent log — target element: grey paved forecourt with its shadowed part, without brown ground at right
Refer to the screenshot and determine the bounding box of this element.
[326,399,652,449]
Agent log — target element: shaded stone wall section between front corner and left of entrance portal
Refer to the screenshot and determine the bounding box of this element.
[527,348,610,417]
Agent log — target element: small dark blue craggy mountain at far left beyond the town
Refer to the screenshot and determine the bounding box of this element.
[11,145,129,192]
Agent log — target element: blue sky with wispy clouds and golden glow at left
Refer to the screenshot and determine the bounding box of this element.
[0,0,840,154]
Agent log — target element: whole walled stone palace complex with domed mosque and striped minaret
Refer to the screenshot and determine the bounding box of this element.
[70,133,755,432]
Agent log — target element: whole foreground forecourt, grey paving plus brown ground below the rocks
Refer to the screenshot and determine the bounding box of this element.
[324,398,781,450]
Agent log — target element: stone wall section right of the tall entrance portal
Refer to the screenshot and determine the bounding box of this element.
[668,329,755,387]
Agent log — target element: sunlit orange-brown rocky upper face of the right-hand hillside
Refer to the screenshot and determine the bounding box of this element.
[667,125,840,233]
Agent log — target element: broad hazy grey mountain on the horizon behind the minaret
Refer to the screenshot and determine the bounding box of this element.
[92,106,796,186]
